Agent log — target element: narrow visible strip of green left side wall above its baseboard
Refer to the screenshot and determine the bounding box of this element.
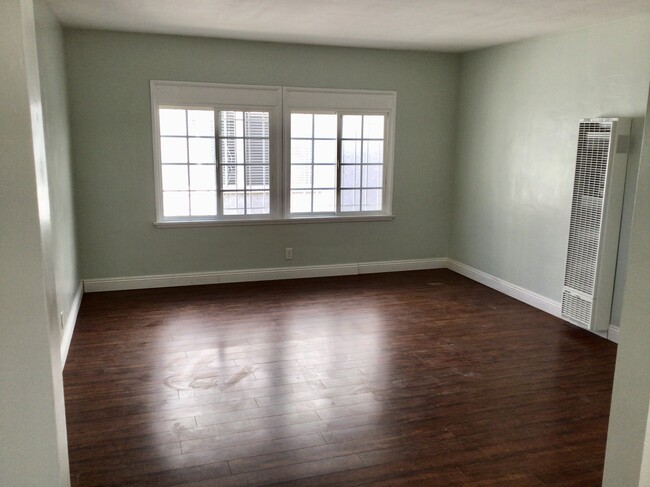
[34,0,80,346]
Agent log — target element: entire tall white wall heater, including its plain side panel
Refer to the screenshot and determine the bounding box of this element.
[562,119,630,331]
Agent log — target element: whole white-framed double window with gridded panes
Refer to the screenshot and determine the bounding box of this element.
[151,81,396,225]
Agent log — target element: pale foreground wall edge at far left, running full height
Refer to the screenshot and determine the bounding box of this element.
[0,0,70,487]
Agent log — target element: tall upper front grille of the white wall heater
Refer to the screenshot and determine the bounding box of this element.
[564,122,612,296]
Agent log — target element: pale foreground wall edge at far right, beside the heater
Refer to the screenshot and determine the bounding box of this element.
[603,87,650,487]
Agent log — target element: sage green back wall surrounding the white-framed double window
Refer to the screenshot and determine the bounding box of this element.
[65,30,458,278]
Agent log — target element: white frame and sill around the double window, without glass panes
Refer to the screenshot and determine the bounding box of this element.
[150,80,397,227]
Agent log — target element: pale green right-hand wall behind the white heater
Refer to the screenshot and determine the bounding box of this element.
[450,15,650,308]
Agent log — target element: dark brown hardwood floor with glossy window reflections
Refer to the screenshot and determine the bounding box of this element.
[64,270,616,487]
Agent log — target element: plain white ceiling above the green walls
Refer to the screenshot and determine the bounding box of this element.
[48,0,650,52]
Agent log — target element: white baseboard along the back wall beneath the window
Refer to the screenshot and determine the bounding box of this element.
[83,257,447,293]
